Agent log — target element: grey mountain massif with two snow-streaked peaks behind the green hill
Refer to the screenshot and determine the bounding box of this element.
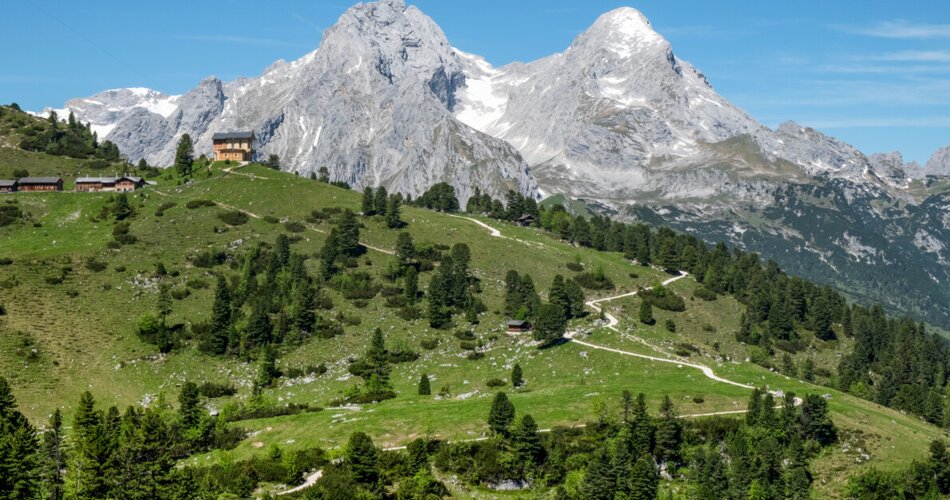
[41,0,950,325]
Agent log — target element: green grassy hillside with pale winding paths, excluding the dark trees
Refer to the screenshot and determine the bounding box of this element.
[0,160,943,495]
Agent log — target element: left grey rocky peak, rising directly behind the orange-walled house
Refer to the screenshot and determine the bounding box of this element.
[57,0,537,203]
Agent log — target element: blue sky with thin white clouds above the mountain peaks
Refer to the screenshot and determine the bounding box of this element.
[0,0,950,162]
